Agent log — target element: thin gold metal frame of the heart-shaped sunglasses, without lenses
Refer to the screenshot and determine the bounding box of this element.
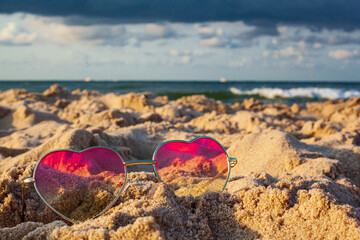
[21,136,237,224]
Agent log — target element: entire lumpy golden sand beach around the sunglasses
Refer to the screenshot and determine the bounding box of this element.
[0,85,360,239]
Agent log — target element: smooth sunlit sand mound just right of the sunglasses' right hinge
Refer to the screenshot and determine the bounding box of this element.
[228,130,340,178]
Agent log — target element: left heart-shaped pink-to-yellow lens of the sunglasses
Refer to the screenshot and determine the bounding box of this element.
[35,147,125,221]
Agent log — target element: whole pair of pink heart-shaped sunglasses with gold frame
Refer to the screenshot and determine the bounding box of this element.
[21,137,237,223]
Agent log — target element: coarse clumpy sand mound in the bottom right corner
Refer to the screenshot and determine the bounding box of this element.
[234,176,360,239]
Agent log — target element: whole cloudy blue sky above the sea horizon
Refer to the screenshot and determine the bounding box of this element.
[0,0,360,81]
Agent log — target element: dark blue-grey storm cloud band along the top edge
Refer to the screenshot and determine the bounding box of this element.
[0,0,360,31]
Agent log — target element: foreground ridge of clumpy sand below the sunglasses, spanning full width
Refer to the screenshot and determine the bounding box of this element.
[0,175,360,239]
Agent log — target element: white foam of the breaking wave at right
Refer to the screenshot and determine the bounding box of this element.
[229,87,360,99]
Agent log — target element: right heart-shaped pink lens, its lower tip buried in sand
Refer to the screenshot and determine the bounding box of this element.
[155,138,229,196]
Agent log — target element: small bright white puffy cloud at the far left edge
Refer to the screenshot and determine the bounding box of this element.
[0,22,37,45]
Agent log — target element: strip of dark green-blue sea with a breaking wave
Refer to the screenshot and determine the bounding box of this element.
[0,81,360,104]
